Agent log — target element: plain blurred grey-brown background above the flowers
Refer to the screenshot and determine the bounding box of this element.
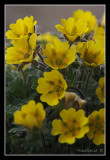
[5,4,105,34]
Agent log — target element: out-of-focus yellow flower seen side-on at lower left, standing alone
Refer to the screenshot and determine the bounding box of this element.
[14,100,46,130]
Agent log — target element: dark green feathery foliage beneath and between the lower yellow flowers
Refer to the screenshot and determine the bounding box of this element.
[6,57,104,154]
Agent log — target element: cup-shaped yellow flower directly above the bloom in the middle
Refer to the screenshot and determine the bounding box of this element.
[43,39,76,69]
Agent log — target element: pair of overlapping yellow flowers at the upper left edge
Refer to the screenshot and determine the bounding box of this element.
[5,16,38,69]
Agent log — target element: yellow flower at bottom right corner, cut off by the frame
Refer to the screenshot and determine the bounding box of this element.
[87,108,105,145]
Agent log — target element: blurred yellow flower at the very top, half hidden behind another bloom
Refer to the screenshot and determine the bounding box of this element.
[73,9,97,34]
